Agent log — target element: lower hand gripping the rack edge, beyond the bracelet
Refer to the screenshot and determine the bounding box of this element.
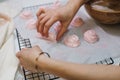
[16,46,42,72]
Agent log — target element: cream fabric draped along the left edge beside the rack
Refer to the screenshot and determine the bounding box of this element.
[0,6,18,80]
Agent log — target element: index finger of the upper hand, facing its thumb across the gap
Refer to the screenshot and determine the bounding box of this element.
[43,18,57,37]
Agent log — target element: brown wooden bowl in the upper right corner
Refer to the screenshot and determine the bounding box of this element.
[85,0,120,24]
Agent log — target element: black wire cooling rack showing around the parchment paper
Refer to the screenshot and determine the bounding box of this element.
[16,3,120,80]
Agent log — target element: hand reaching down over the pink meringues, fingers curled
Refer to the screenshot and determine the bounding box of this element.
[37,5,75,40]
